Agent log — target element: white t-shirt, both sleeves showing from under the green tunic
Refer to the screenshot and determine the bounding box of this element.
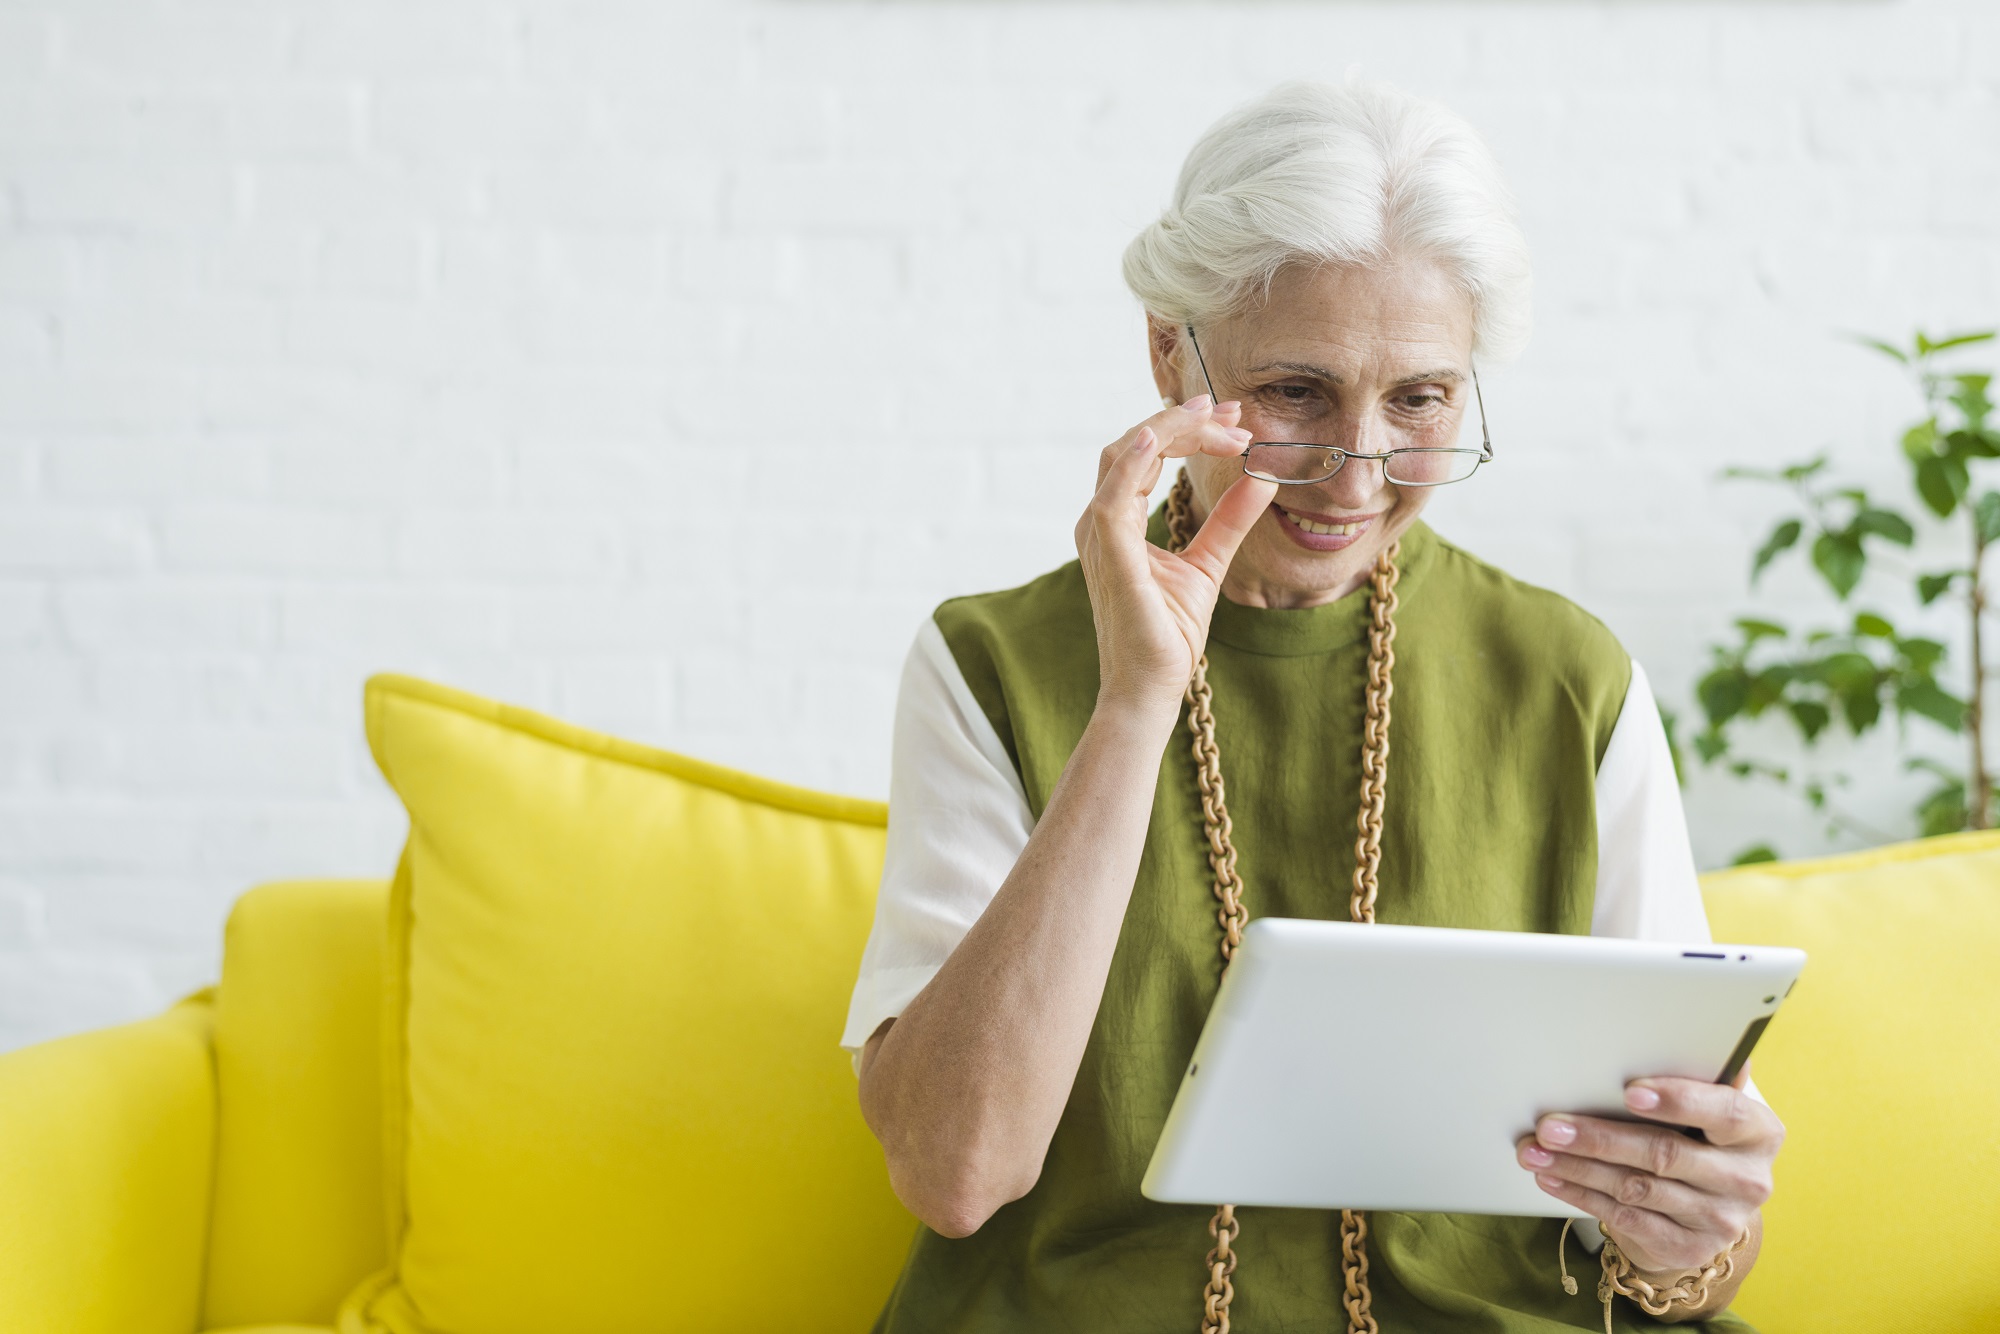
[840,620,1710,1056]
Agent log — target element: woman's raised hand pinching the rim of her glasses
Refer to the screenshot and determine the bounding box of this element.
[1076,394,1278,732]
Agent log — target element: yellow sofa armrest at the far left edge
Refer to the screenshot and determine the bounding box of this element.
[0,992,216,1334]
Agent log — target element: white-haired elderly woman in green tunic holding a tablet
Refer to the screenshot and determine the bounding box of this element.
[844,84,1782,1334]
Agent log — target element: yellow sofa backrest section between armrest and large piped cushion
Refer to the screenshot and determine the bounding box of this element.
[202,880,388,1326]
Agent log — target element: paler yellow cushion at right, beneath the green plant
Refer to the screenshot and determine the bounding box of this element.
[1704,832,2000,1334]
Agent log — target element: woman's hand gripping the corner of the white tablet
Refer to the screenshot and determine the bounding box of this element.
[1516,1072,1784,1274]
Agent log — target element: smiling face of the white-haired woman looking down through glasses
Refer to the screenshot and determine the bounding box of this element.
[1152,262,1478,606]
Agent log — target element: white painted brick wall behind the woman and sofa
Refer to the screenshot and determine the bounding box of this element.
[0,0,2000,1048]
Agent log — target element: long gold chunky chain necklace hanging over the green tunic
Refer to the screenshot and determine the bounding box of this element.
[1166,470,1400,1334]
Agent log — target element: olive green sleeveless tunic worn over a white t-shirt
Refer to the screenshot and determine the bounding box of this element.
[876,514,1748,1334]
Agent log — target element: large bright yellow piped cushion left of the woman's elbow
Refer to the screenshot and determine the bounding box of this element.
[340,676,914,1334]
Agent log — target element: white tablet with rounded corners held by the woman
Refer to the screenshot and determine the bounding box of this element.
[1140,918,1806,1218]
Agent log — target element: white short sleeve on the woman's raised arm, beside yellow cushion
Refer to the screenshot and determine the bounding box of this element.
[840,620,1034,1054]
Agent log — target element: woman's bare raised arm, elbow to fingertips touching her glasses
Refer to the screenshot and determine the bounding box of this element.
[860,396,1274,1236]
